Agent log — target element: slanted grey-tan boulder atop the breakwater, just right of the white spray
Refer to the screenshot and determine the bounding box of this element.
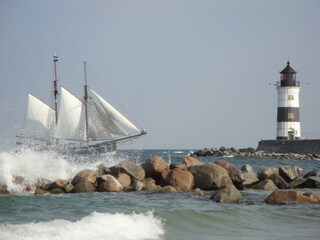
[110,160,145,180]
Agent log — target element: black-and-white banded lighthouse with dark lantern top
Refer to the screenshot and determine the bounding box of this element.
[277,61,301,140]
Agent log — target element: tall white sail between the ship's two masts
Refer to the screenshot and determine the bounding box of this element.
[54,87,85,140]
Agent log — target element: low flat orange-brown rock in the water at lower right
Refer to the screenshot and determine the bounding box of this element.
[266,190,312,204]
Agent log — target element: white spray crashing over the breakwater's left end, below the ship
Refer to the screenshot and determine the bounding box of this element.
[0,149,120,193]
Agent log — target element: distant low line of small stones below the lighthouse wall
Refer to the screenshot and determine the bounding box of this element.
[192,146,320,160]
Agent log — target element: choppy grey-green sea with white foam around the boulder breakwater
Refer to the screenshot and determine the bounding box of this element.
[0,149,320,240]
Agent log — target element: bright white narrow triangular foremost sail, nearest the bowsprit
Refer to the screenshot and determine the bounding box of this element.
[90,89,140,132]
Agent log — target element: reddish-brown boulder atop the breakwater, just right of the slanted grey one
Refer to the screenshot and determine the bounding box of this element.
[141,156,169,184]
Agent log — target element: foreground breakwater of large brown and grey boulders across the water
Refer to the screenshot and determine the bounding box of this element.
[0,156,320,204]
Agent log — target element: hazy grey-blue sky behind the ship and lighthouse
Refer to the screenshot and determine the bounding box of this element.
[0,0,320,149]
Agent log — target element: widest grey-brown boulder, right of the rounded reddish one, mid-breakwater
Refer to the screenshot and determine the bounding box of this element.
[188,164,232,190]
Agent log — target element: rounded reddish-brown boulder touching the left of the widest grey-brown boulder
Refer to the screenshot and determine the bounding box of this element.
[169,168,194,190]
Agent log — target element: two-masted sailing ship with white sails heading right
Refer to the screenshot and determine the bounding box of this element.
[17,54,147,154]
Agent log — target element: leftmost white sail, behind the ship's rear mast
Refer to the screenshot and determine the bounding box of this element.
[21,93,55,140]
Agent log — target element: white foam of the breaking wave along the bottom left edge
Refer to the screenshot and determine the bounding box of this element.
[0,212,164,240]
